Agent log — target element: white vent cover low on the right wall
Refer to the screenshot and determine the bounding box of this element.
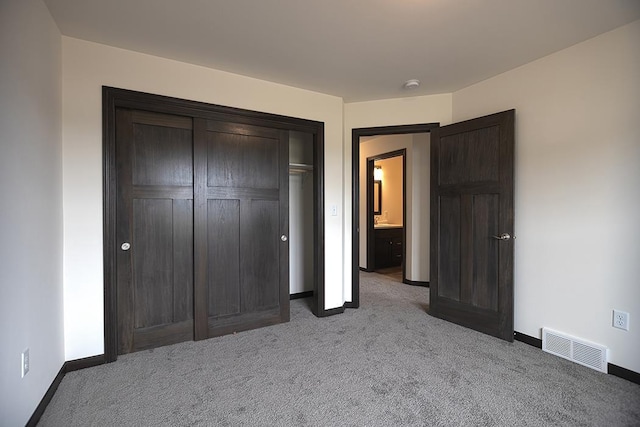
[542,328,609,373]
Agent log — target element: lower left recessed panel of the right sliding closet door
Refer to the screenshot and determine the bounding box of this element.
[207,200,241,317]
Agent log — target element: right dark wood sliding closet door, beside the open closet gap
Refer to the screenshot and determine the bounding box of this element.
[194,119,289,339]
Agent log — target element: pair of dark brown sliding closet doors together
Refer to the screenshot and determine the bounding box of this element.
[115,108,289,354]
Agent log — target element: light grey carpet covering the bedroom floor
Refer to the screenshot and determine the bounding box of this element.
[39,273,640,427]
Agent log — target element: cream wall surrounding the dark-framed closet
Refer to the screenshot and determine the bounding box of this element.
[62,37,344,360]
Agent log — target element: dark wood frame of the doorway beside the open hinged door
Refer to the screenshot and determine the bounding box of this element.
[345,123,440,308]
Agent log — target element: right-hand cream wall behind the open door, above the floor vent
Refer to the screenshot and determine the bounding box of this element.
[453,21,640,372]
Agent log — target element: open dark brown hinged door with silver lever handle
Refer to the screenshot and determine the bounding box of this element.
[429,110,515,341]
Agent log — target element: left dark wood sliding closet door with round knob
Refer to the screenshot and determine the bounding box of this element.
[116,109,193,354]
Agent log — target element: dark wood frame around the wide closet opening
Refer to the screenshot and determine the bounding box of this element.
[102,86,325,362]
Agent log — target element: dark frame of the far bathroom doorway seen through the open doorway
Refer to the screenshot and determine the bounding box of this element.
[366,148,407,281]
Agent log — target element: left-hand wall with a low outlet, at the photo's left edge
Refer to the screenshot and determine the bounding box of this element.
[0,0,64,426]
